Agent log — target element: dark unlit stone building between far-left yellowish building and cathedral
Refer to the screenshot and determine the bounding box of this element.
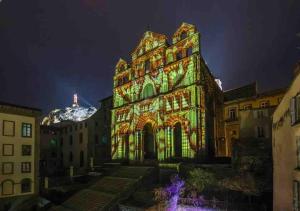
[41,97,112,176]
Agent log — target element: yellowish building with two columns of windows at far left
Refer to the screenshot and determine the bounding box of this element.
[0,102,41,209]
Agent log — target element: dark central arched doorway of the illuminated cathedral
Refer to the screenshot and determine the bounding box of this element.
[143,123,156,159]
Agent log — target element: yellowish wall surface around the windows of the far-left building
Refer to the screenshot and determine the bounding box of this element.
[0,113,37,198]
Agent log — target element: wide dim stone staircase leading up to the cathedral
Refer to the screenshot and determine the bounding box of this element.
[50,166,155,211]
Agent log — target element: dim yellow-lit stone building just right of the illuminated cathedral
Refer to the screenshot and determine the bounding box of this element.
[222,83,286,157]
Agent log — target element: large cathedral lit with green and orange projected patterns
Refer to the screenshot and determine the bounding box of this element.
[111,23,224,162]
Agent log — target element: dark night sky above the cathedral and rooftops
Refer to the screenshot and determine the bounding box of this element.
[0,0,300,112]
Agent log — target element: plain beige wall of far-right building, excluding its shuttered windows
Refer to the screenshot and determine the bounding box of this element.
[272,74,300,211]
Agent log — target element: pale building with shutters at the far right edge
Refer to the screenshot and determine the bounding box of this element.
[272,63,300,211]
